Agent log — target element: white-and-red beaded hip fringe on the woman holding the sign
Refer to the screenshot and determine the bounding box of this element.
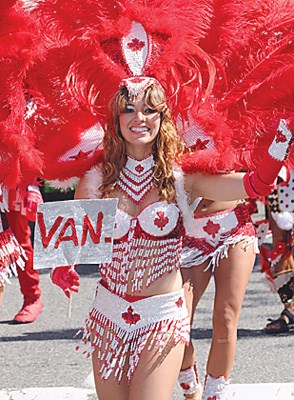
[75,287,190,382]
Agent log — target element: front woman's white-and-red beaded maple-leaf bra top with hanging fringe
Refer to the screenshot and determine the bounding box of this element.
[81,164,185,297]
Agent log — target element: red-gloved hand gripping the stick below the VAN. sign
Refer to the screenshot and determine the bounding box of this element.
[50,267,80,298]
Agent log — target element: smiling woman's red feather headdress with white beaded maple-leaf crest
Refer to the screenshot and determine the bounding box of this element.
[31,0,214,117]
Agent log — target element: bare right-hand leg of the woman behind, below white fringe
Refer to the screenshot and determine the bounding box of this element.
[207,242,255,379]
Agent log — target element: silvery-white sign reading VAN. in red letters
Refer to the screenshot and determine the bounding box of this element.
[34,199,118,269]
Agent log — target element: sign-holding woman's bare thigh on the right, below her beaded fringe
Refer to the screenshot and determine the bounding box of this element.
[129,337,185,400]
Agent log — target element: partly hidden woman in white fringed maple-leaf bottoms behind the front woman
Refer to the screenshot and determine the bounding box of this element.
[179,199,257,400]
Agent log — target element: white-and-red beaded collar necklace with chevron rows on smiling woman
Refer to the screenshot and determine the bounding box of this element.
[117,155,154,205]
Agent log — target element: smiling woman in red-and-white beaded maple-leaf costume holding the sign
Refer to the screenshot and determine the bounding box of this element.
[52,77,290,400]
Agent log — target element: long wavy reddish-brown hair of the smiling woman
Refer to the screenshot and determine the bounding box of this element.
[100,84,184,202]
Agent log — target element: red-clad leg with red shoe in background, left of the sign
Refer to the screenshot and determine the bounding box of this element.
[7,211,43,323]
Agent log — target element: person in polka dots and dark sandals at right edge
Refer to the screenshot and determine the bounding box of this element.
[261,170,294,334]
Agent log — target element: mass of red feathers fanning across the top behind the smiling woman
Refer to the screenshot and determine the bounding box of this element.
[0,0,294,188]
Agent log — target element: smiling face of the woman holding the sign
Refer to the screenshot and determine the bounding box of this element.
[119,97,160,156]
